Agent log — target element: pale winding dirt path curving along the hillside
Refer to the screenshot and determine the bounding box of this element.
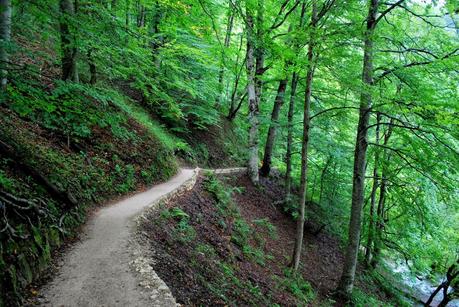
[41,169,199,306]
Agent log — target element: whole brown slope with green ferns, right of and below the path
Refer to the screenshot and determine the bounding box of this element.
[141,174,402,306]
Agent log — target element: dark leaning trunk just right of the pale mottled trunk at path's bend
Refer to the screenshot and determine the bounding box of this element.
[260,79,288,177]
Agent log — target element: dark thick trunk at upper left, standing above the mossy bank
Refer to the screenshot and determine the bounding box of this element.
[59,0,79,82]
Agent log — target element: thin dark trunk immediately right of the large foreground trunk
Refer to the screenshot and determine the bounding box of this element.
[365,113,381,267]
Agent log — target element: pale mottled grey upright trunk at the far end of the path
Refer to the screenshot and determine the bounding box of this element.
[246,10,259,184]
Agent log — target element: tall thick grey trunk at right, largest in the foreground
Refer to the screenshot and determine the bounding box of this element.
[337,0,379,300]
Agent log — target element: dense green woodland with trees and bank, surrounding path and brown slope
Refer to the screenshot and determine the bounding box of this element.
[0,0,459,306]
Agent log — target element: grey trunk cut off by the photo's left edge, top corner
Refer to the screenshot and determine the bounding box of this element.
[0,0,11,90]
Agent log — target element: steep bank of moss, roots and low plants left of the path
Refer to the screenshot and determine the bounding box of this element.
[0,85,178,306]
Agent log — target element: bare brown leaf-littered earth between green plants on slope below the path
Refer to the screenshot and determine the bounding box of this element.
[138,175,358,306]
